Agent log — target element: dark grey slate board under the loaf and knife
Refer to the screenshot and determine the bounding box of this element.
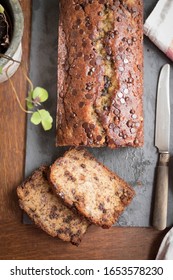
[24,0,173,227]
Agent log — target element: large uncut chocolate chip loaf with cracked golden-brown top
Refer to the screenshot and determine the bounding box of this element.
[56,0,144,148]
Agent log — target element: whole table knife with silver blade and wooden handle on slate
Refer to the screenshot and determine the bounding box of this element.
[153,64,170,230]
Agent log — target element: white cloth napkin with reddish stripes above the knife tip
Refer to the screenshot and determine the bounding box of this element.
[144,0,173,60]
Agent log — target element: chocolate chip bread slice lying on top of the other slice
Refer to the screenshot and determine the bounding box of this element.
[50,148,134,228]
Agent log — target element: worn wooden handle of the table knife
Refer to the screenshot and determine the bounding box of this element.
[153,153,170,230]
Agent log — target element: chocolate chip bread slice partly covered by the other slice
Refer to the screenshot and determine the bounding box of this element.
[17,166,89,245]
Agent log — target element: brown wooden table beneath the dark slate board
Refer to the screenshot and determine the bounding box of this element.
[0,0,167,260]
